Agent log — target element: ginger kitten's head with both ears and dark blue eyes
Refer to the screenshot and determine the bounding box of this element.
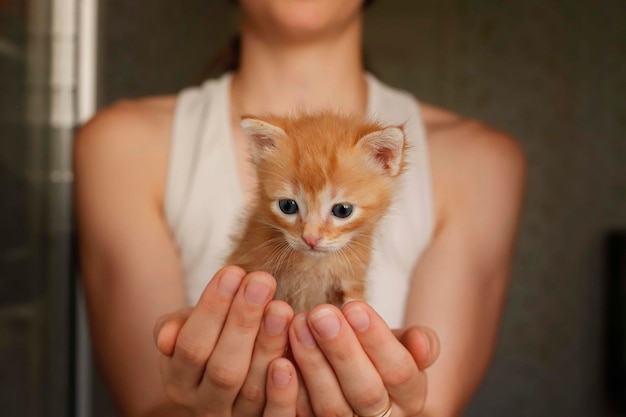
[242,113,406,256]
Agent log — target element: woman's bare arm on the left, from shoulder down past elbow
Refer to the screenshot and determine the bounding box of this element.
[74,102,185,416]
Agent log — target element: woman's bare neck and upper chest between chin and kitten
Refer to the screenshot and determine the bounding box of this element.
[231,19,367,118]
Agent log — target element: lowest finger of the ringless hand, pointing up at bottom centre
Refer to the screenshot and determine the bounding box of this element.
[263,358,298,417]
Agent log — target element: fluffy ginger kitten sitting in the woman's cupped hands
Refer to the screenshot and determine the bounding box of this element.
[227,112,407,313]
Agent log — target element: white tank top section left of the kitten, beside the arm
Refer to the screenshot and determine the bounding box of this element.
[164,73,243,303]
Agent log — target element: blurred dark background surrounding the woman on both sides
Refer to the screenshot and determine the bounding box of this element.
[0,0,626,417]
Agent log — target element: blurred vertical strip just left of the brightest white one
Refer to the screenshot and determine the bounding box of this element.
[45,0,78,416]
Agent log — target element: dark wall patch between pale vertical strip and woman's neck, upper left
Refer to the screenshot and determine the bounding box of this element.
[100,0,236,104]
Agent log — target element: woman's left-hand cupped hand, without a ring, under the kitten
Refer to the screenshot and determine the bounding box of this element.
[155,266,298,417]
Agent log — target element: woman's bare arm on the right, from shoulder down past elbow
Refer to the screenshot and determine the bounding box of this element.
[406,108,525,417]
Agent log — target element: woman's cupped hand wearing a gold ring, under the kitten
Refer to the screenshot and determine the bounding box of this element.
[289,301,439,417]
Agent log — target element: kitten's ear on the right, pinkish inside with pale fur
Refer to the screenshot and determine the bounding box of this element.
[358,127,406,177]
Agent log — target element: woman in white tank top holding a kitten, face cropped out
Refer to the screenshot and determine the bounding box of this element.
[75,0,524,417]
